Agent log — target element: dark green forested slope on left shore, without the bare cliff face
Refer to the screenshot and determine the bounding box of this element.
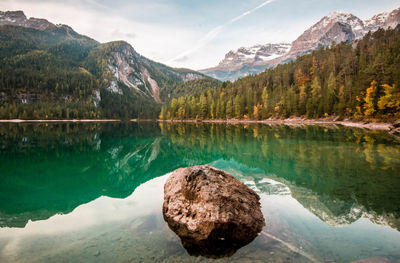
[0,25,172,119]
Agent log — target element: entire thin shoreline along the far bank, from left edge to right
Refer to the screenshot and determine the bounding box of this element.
[0,118,396,131]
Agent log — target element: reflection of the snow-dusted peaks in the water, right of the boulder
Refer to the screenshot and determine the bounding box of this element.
[205,159,400,229]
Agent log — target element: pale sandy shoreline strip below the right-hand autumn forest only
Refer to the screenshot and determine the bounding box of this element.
[158,118,395,131]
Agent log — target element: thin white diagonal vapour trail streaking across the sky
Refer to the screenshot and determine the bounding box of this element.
[168,0,275,63]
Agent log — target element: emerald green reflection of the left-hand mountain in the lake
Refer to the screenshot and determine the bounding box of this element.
[0,123,167,227]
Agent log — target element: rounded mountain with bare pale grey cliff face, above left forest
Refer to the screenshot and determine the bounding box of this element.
[87,41,205,102]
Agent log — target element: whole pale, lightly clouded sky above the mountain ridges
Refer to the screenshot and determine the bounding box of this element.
[0,0,400,70]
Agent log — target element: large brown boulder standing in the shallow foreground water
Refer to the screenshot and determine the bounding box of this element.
[163,165,265,257]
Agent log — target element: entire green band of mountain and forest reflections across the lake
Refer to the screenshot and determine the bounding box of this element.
[0,123,400,229]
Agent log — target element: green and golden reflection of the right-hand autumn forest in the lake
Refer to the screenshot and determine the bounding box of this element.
[161,123,400,228]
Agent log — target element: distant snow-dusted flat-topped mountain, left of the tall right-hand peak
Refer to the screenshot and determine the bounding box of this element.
[200,43,291,81]
